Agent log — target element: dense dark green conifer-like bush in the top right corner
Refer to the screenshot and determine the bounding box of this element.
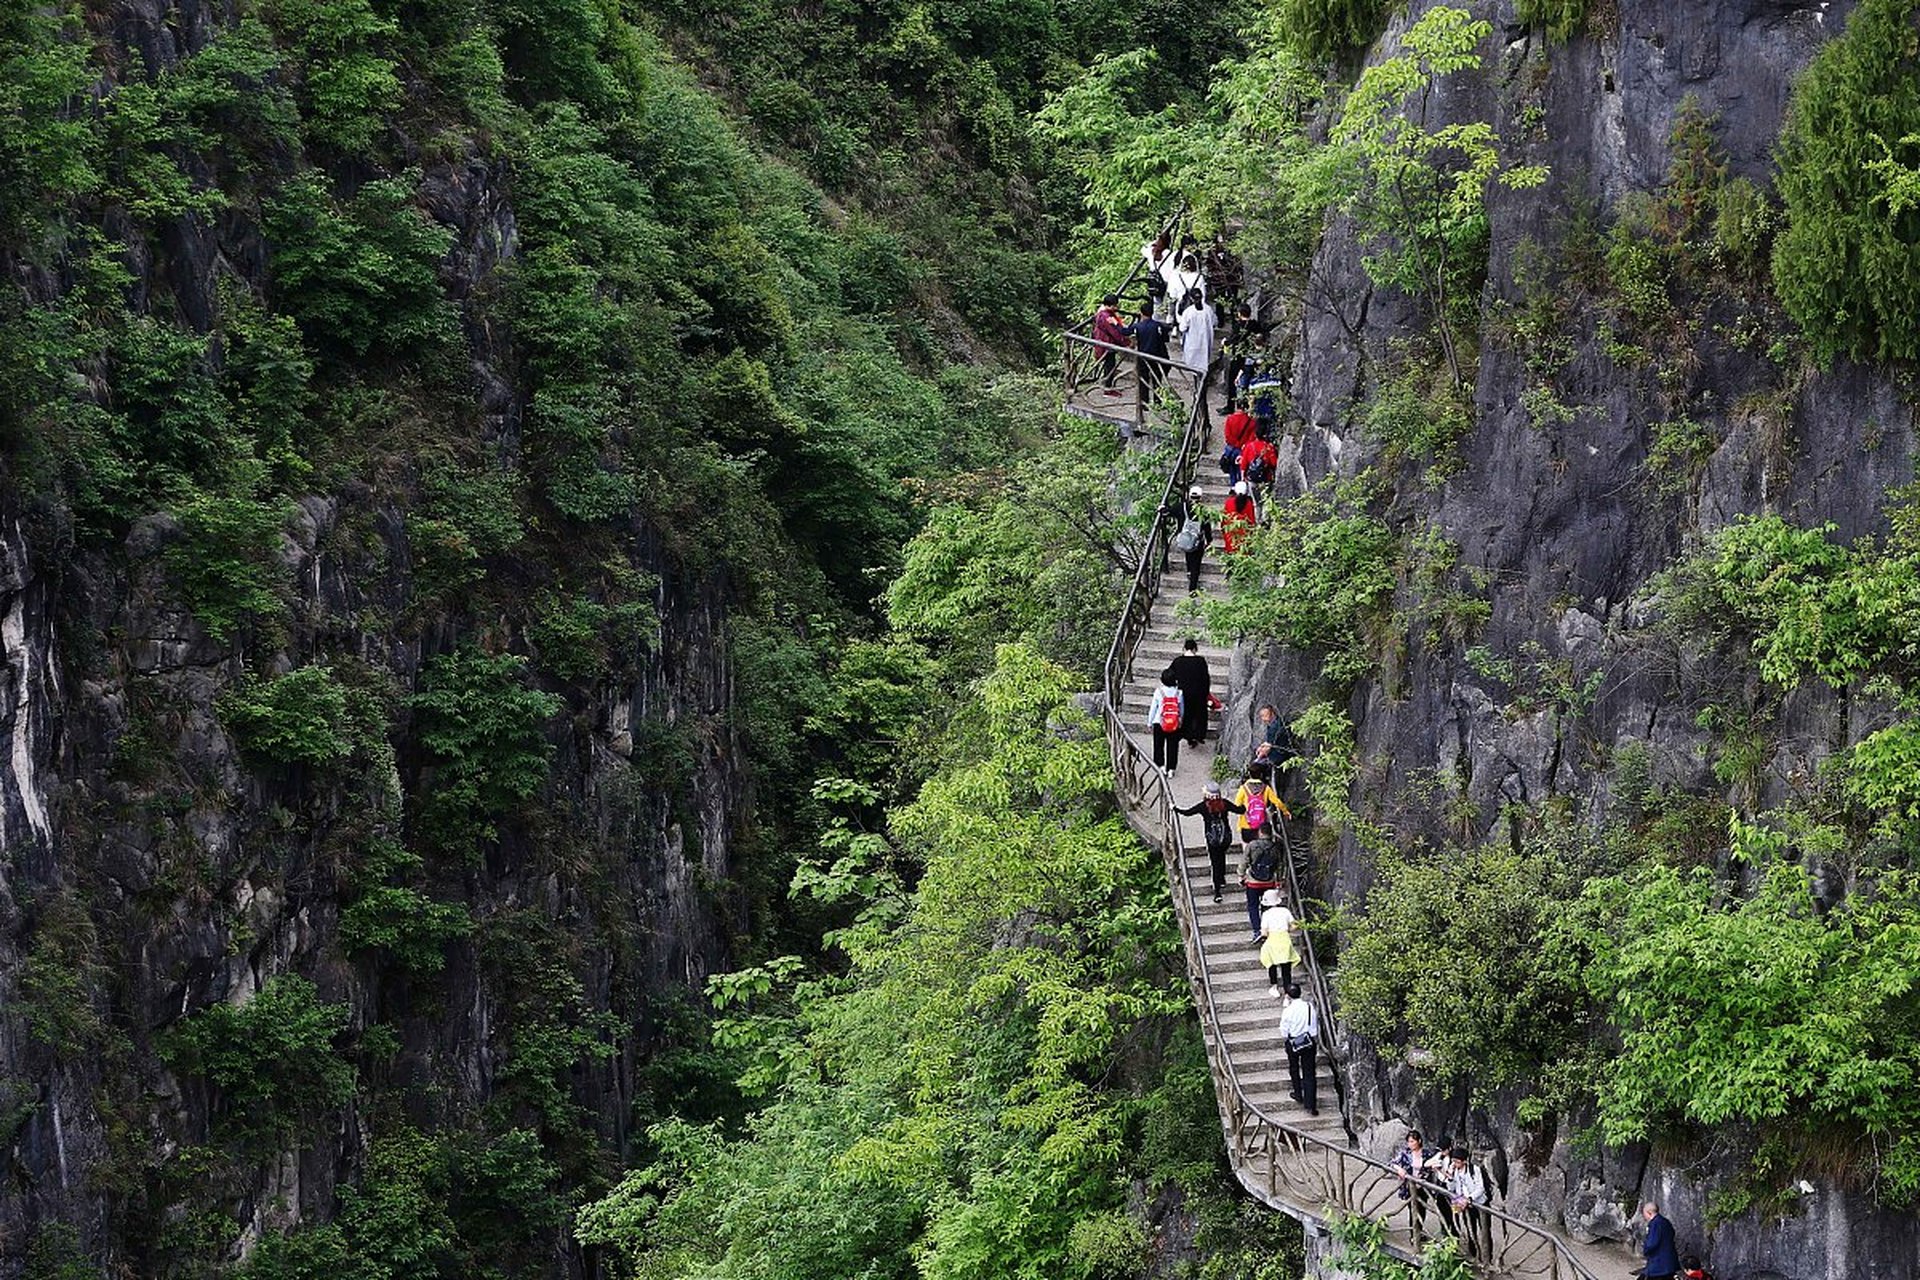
[1774,0,1920,363]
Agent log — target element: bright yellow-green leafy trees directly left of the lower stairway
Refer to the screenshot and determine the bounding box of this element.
[578,645,1282,1280]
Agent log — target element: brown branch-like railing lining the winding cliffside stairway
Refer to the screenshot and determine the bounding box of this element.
[1098,353,1599,1280]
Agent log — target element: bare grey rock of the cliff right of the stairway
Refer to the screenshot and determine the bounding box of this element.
[1229,0,1920,1280]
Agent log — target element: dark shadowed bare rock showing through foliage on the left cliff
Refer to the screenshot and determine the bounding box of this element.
[0,0,749,1276]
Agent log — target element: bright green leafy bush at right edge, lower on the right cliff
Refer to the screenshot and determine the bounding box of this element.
[1586,865,1920,1203]
